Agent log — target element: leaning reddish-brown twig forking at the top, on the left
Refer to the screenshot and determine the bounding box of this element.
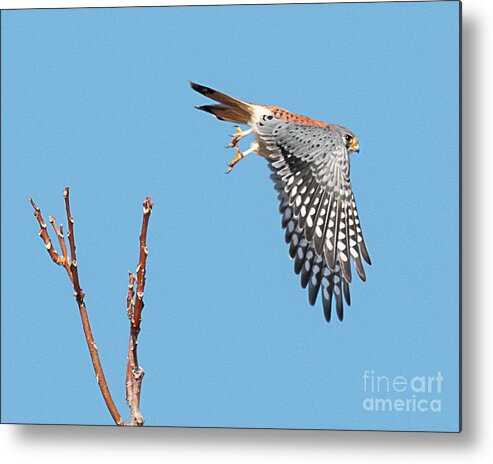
[30,187,126,425]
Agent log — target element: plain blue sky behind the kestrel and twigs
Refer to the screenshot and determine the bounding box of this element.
[1,2,459,430]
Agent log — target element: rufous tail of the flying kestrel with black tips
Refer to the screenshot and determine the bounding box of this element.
[190,82,253,124]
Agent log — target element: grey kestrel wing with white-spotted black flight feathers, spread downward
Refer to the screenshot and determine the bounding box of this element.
[256,116,371,320]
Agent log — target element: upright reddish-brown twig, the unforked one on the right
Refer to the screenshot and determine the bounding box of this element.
[126,197,153,426]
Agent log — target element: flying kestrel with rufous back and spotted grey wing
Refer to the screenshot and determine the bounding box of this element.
[191,82,371,321]
